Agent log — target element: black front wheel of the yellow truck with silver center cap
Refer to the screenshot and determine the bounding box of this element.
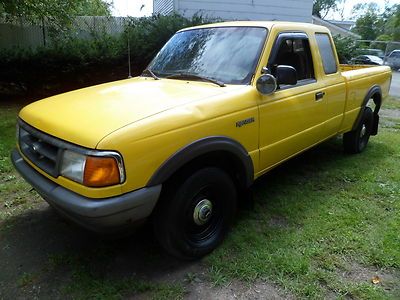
[153,167,237,260]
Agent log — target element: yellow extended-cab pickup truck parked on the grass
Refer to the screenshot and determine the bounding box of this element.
[12,22,391,259]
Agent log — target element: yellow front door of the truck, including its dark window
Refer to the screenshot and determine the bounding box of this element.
[259,32,327,172]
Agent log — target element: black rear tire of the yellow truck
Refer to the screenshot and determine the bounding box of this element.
[343,107,374,153]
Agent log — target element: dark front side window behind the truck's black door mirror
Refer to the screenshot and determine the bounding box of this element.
[269,33,315,83]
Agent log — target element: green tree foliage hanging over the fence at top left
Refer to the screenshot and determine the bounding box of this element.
[0,0,110,28]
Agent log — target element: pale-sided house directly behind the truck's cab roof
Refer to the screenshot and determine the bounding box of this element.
[153,0,313,23]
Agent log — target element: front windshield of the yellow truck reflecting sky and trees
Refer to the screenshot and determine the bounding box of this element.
[148,27,267,84]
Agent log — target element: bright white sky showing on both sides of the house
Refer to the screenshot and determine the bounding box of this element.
[110,0,400,20]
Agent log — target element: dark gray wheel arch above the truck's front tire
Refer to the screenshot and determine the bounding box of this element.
[147,136,254,189]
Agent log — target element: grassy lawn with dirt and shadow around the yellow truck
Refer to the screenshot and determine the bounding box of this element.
[0,98,400,299]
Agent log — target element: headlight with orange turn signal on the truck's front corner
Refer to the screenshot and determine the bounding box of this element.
[60,150,125,187]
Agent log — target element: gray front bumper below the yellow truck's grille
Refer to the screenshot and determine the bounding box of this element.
[11,149,161,232]
